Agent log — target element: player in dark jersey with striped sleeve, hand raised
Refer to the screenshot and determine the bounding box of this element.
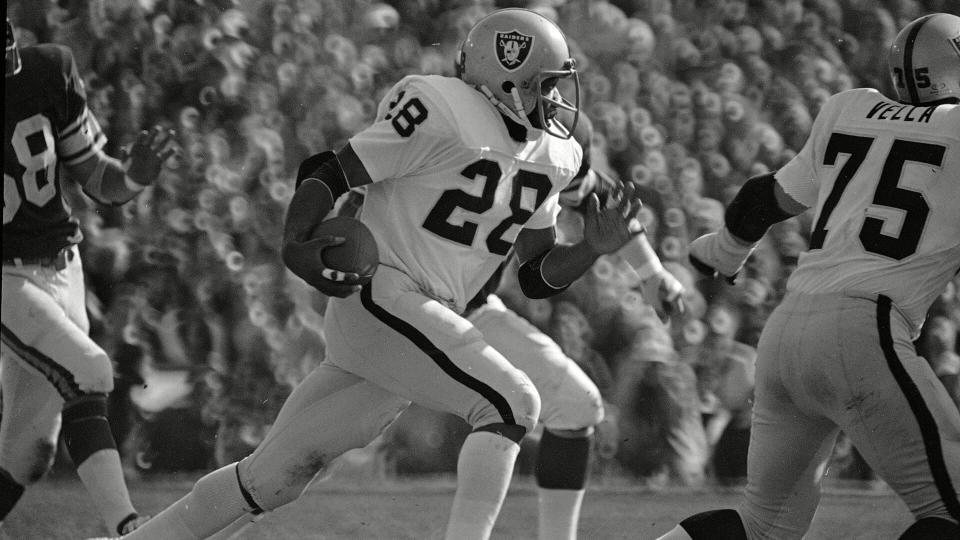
[0,18,174,534]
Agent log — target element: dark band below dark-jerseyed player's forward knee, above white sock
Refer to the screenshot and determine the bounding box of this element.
[61,394,117,467]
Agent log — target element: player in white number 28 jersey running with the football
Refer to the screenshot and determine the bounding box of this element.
[110,9,640,540]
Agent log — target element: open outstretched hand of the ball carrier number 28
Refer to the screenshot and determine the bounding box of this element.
[583,182,643,254]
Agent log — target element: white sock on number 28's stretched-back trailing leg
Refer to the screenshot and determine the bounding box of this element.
[124,463,249,540]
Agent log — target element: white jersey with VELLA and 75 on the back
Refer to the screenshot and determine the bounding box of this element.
[776,88,960,331]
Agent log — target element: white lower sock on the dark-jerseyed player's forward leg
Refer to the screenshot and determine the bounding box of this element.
[77,448,136,534]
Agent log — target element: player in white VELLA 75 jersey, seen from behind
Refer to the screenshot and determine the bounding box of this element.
[661,13,960,540]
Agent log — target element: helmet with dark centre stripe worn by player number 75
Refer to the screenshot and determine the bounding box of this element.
[889,13,960,104]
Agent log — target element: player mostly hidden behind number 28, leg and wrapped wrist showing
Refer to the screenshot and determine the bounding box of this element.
[296,112,684,540]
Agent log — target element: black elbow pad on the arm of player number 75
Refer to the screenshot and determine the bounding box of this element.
[723,172,793,242]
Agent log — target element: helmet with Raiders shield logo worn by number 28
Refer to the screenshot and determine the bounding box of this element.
[456,8,580,139]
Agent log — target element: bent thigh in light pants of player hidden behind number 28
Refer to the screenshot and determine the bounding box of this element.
[469,296,603,430]
